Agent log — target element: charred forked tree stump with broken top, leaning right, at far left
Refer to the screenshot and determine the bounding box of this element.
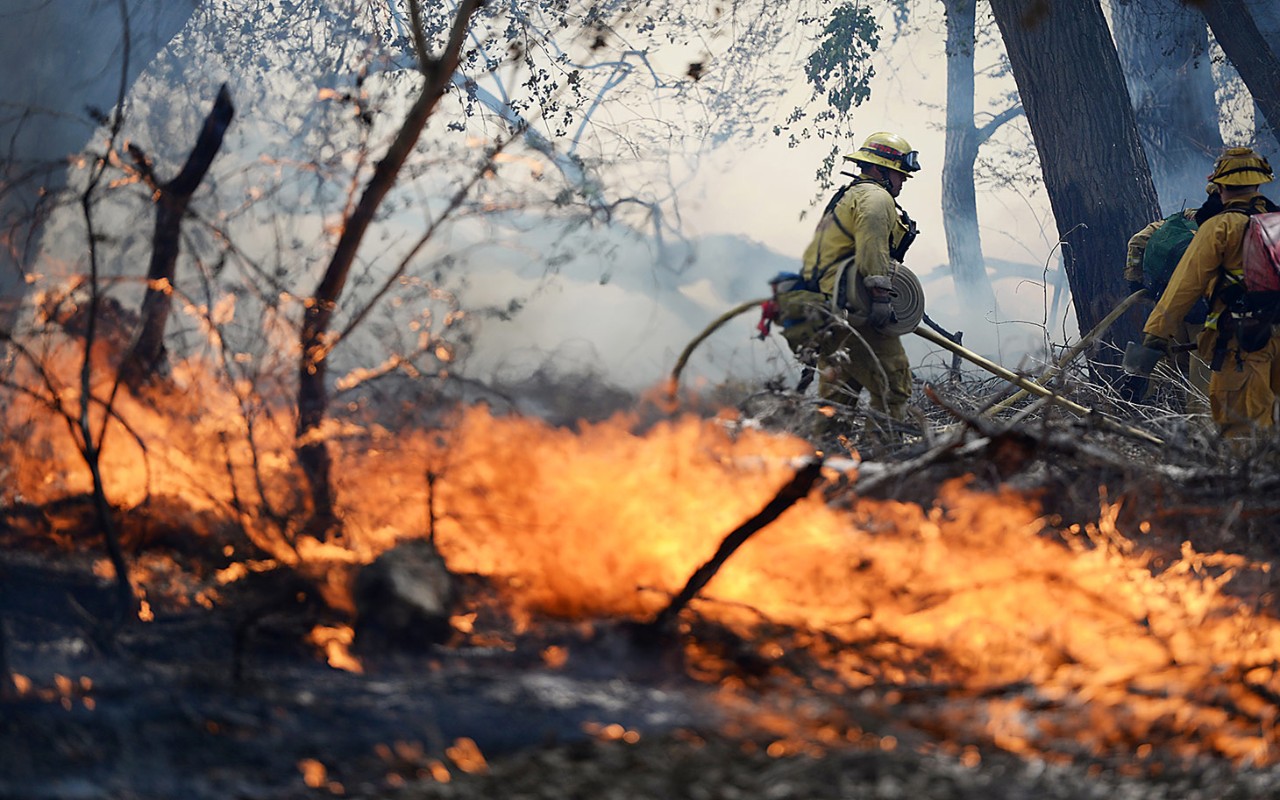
[120,83,236,388]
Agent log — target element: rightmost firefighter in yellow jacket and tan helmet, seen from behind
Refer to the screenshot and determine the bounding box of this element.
[1125,147,1280,438]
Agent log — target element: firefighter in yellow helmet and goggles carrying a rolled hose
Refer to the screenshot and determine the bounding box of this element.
[785,133,920,433]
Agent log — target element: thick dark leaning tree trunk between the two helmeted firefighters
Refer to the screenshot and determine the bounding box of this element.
[991,0,1160,350]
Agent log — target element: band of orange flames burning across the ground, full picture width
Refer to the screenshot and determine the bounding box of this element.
[5,340,1280,764]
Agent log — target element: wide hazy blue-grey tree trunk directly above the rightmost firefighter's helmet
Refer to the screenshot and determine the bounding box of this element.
[1111,0,1222,214]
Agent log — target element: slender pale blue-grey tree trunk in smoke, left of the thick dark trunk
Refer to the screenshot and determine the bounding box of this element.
[942,0,996,312]
